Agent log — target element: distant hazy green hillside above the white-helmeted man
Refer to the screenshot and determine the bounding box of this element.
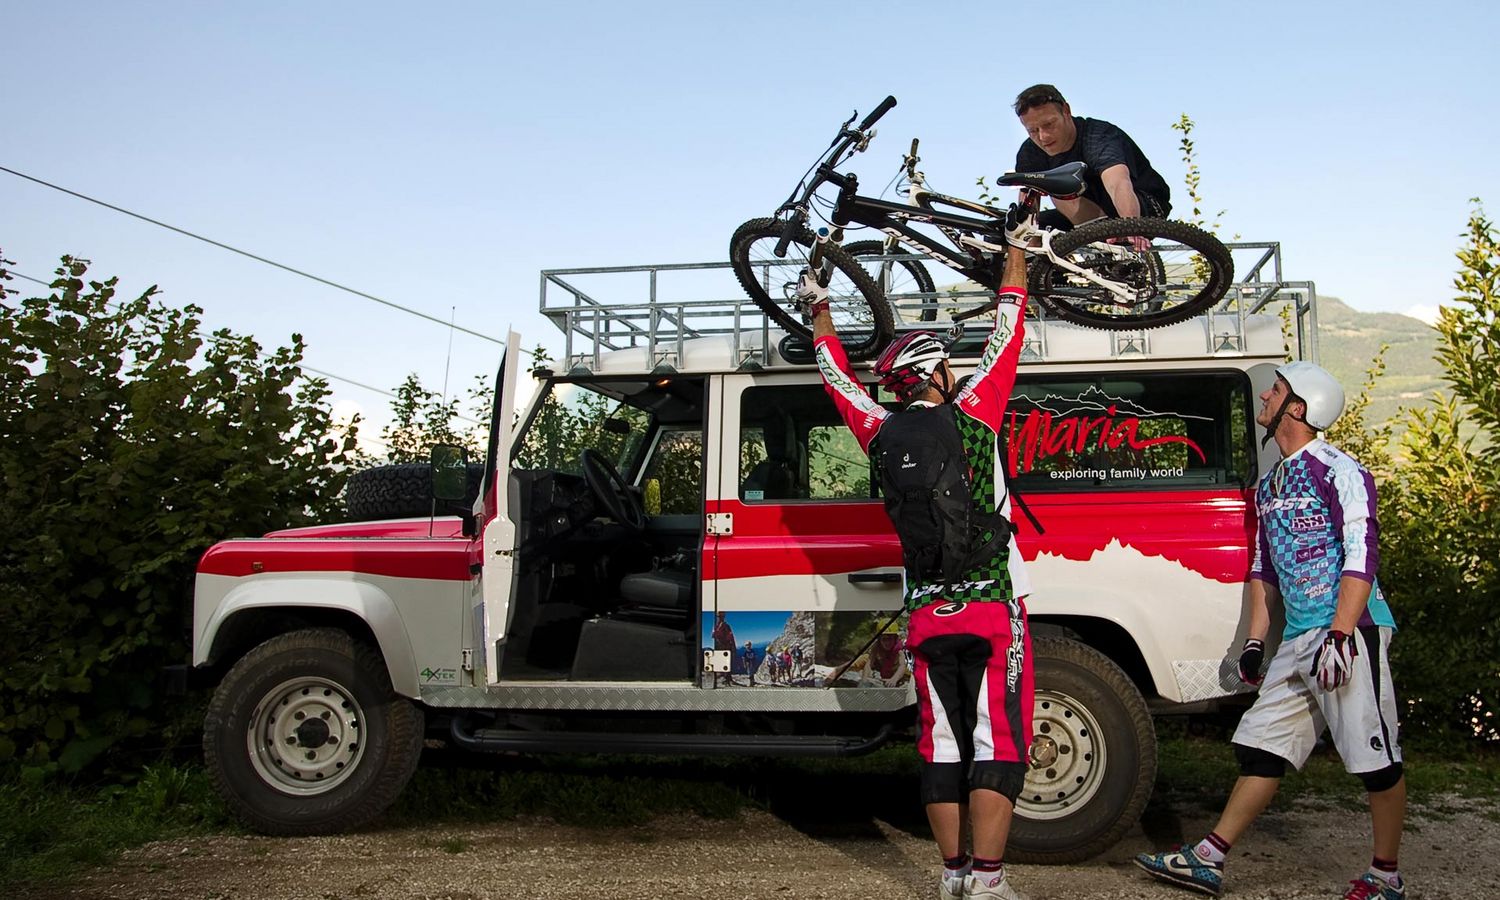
[1317,296,1446,426]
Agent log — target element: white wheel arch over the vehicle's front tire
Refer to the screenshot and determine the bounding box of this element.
[194,579,422,699]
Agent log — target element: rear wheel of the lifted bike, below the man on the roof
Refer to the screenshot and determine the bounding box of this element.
[1031,219,1235,332]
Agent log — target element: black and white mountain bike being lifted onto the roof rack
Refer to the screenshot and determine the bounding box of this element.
[729,98,1235,357]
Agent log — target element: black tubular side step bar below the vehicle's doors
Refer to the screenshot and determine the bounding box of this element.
[449,719,896,756]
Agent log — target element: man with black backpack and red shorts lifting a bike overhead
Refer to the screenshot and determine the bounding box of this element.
[804,207,1034,900]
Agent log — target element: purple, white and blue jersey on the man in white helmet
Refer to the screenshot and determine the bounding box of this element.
[1250,440,1397,639]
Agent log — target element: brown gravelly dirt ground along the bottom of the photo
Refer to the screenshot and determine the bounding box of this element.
[32,800,1500,900]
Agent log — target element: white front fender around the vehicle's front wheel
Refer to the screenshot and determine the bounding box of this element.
[192,573,420,699]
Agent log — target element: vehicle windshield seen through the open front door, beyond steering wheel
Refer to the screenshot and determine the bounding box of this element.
[516,383,651,476]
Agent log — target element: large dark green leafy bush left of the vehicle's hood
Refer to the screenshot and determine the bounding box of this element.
[0,257,356,777]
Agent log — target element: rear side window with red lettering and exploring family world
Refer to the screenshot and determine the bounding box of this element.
[1004,371,1254,492]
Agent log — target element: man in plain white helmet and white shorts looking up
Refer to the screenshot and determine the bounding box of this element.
[1136,362,1406,900]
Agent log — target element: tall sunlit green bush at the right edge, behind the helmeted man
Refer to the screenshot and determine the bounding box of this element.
[1331,209,1500,746]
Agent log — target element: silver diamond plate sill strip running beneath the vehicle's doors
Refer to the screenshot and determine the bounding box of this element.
[422,683,917,713]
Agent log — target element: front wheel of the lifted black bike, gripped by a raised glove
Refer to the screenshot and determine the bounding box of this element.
[729,219,896,359]
